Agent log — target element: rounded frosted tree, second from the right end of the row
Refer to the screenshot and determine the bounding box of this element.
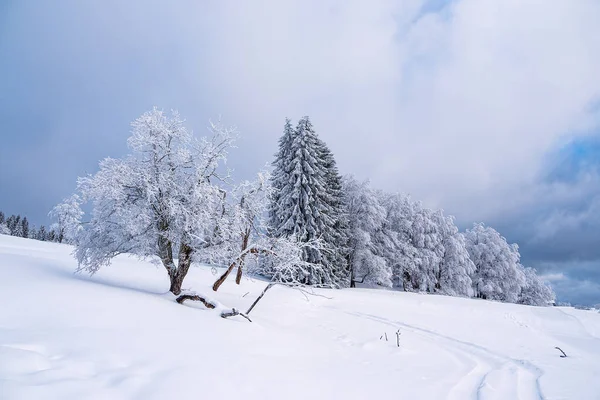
[465,224,526,303]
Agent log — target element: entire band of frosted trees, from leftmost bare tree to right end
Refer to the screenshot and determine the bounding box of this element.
[27,108,554,305]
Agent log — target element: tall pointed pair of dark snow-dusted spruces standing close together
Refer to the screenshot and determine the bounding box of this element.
[269,117,348,287]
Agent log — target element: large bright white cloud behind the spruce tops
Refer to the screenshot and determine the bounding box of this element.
[175,0,600,225]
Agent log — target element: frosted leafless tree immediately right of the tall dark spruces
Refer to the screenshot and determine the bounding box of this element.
[342,175,392,287]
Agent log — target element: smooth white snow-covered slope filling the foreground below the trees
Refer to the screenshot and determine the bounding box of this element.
[0,235,600,400]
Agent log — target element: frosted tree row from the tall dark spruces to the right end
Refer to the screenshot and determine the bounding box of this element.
[259,117,555,305]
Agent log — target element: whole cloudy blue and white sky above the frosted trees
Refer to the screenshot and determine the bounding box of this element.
[0,0,600,304]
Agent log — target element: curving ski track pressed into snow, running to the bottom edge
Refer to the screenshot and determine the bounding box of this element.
[336,311,545,400]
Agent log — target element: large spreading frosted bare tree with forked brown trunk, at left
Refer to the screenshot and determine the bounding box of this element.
[76,108,235,295]
